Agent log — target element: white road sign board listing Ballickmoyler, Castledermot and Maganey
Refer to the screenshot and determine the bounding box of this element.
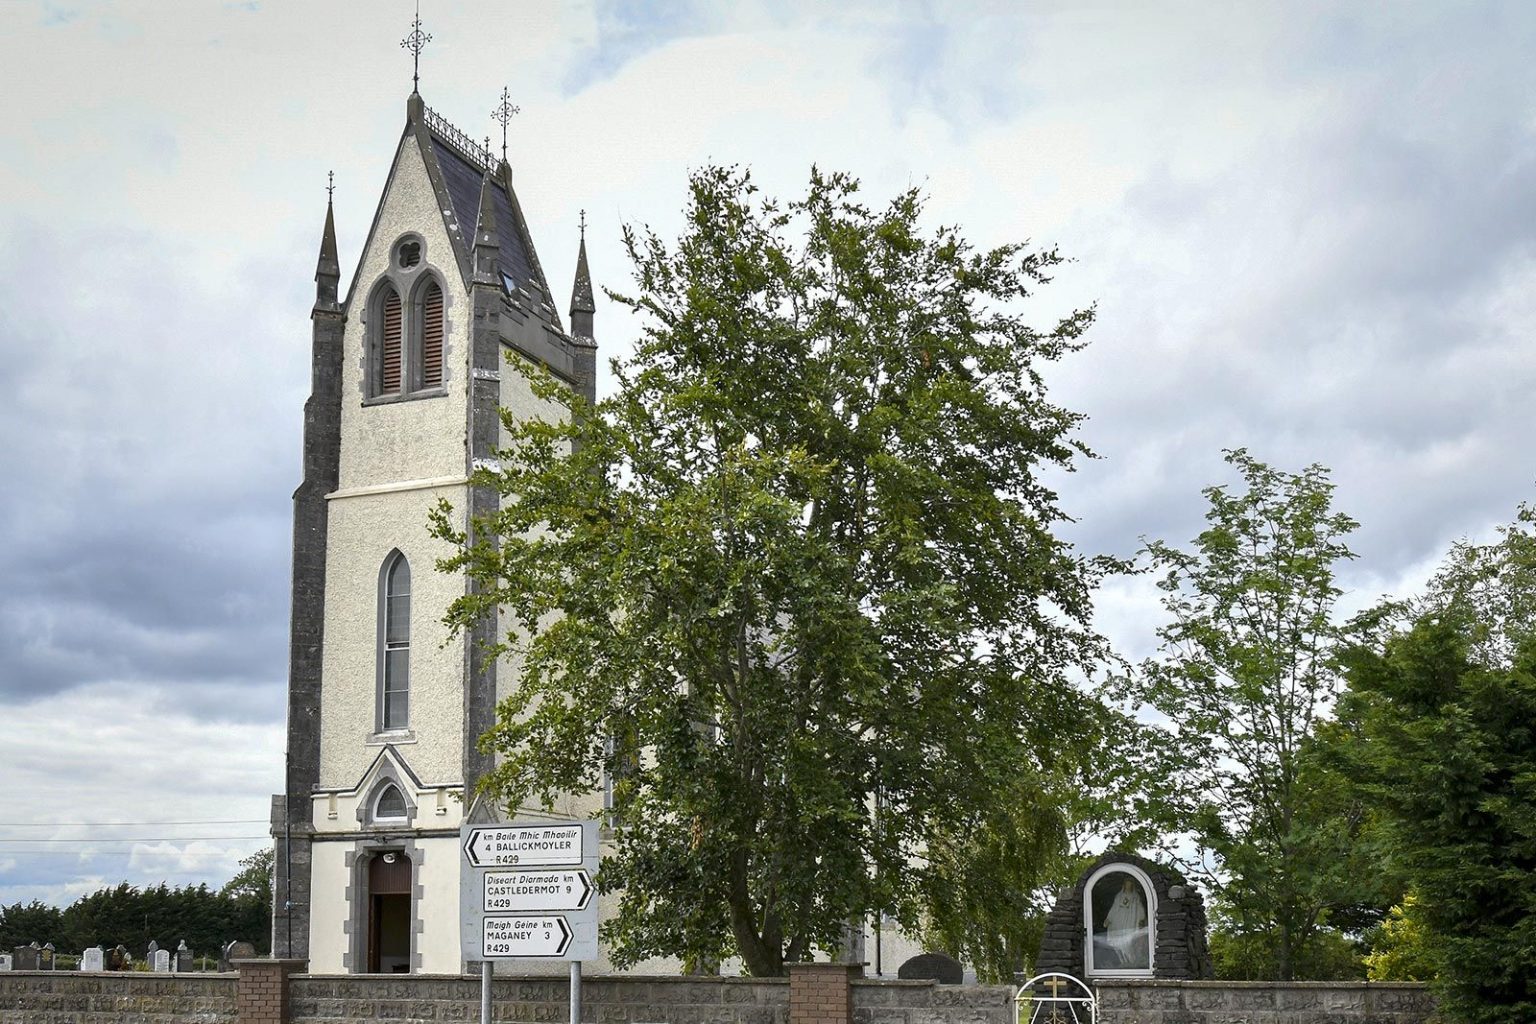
[459,821,598,961]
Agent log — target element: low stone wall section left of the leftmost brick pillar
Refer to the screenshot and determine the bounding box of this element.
[0,970,238,1024]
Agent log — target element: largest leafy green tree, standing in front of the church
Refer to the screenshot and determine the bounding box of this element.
[435,167,1103,975]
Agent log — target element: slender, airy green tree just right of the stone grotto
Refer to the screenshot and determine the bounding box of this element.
[1129,450,1364,979]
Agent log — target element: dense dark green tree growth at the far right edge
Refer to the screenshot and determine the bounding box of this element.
[1341,507,1536,1024]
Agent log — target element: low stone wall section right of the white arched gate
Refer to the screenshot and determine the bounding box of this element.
[1094,979,1436,1024]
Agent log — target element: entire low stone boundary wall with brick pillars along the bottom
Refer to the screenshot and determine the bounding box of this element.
[0,961,1435,1024]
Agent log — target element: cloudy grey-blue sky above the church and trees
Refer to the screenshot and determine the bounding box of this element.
[0,0,1536,903]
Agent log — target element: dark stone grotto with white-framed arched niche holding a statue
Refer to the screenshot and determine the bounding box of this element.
[1035,852,1215,979]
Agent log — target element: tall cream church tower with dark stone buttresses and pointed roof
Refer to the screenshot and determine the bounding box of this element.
[272,85,596,973]
